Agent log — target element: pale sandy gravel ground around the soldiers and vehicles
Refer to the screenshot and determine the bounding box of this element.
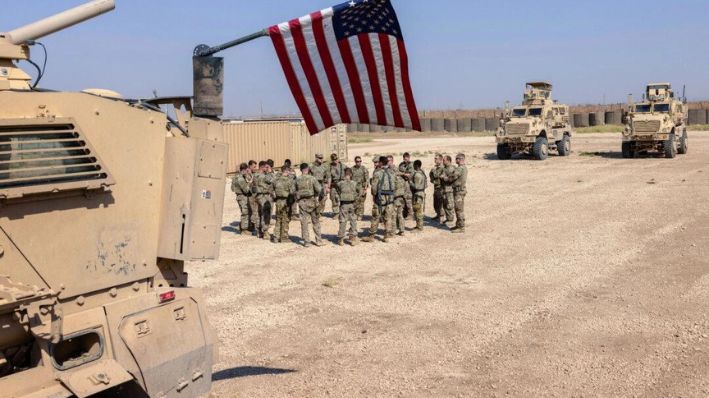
[188,133,709,397]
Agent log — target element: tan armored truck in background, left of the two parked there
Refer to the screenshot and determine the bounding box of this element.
[496,82,572,160]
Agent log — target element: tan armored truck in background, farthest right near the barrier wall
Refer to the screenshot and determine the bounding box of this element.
[622,83,688,158]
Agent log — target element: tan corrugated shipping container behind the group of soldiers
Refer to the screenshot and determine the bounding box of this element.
[222,120,347,173]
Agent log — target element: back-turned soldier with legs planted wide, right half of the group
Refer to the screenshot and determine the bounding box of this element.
[362,156,396,242]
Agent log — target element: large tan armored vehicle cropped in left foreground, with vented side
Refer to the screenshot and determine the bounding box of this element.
[0,0,227,398]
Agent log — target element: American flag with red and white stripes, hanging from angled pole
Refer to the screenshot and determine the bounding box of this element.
[268,0,421,134]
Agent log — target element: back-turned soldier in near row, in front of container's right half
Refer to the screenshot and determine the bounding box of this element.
[295,163,323,247]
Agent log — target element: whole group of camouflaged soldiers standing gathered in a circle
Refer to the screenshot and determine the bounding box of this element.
[231,153,468,247]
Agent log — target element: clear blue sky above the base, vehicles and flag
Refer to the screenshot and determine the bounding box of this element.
[0,0,709,116]
